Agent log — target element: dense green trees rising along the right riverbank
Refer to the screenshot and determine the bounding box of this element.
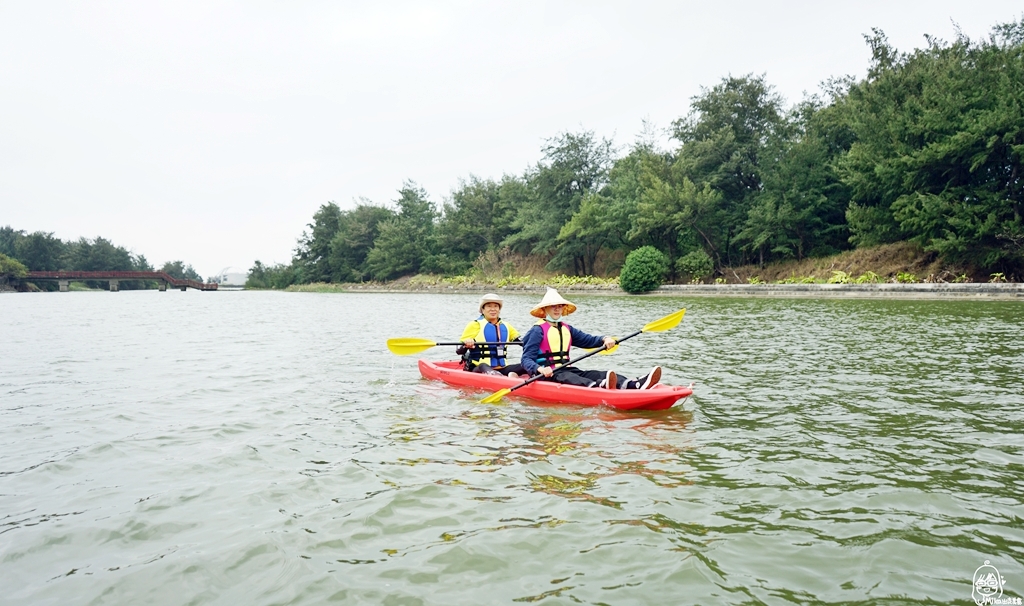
[250,15,1024,288]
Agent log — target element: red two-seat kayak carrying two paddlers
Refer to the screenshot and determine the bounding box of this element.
[420,359,693,410]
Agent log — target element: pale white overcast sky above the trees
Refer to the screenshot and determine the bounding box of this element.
[0,0,1022,276]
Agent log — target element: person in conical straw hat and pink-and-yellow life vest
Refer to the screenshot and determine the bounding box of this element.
[521,288,662,389]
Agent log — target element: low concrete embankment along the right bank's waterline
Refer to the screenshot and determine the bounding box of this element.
[329,283,1024,301]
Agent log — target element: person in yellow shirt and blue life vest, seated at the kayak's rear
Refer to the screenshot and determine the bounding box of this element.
[456,293,525,378]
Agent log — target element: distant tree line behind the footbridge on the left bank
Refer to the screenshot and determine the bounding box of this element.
[0,225,203,290]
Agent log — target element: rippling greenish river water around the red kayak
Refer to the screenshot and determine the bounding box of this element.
[0,291,1024,605]
